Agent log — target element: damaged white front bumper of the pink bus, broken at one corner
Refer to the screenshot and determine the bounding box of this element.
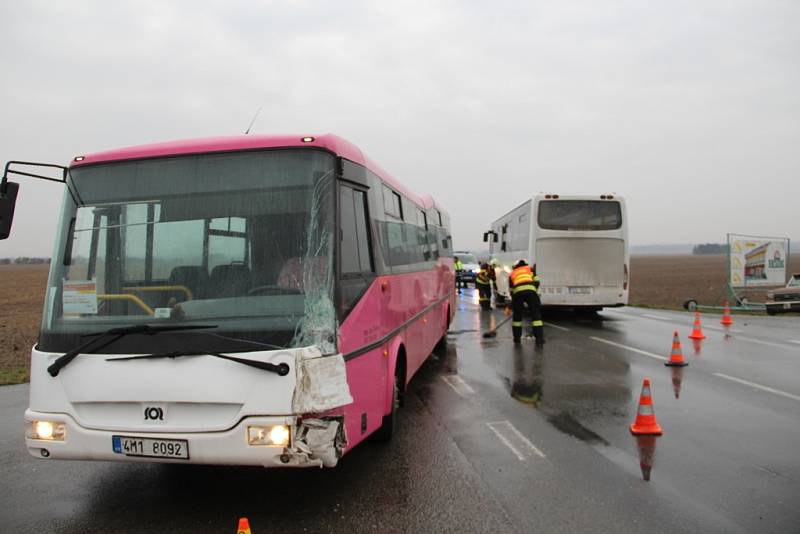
[25,410,346,467]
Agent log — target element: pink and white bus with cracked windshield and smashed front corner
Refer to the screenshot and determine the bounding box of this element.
[0,135,455,467]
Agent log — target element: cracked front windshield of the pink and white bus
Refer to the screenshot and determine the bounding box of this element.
[43,150,335,351]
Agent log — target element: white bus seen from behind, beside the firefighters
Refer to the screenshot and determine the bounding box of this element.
[484,194,630,311]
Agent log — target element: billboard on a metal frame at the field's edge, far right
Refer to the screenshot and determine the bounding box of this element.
[728,234,789,287]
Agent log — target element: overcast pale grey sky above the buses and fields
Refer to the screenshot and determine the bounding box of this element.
[0,0,800,257]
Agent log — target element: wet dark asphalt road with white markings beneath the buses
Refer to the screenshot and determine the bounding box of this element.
[0,289,800,534]
